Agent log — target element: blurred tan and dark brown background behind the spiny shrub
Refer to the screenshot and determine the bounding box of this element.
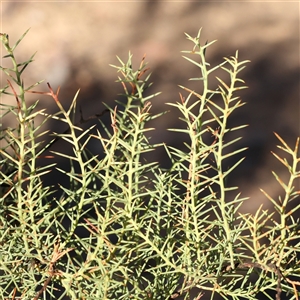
[1,1,300,298]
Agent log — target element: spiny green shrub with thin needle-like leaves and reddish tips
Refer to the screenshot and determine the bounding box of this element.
[0,30,300,299]
